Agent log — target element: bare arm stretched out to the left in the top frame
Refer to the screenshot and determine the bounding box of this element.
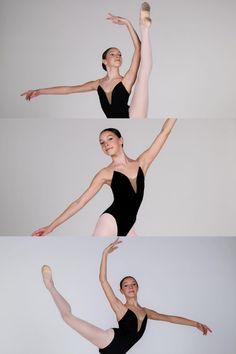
[21,80,99,101]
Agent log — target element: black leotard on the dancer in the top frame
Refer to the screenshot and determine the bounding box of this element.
[97,81,130,118]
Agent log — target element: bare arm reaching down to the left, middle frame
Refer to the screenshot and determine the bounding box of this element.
[32,170,106,236]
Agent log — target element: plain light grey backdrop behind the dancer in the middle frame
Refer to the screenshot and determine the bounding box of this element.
[0,119,236,236]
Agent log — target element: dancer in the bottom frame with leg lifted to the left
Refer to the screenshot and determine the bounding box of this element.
[42,240,211,354]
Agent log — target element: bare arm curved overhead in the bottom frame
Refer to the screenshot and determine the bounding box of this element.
[99,239,126,318]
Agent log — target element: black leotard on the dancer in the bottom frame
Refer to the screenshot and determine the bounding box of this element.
[99,309,147,354]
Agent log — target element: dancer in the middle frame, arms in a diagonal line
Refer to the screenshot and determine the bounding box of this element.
[33,118,176,236]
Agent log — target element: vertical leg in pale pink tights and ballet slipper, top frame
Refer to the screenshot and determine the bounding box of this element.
[129,2,152,118]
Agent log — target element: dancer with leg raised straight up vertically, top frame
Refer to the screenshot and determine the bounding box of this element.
[21,3,152,118]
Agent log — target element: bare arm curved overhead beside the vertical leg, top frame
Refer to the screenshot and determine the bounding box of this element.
[107,13,141,92]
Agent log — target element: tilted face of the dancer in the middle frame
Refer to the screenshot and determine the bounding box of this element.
[99,131,123,156]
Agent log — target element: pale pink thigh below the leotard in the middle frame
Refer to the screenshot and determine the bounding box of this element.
[93,213,118,236]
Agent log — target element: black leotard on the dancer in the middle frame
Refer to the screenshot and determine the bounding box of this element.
[103,167,144,236]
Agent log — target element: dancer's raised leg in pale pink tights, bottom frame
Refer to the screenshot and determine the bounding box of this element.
[42,266,114,348]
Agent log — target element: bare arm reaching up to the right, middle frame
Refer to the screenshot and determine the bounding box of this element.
[137,118,177,173]
